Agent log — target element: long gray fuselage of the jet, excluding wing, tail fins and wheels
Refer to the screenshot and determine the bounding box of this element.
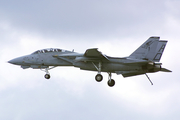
[9,49,158,74]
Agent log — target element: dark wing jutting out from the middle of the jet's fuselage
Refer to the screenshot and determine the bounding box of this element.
[84,48,109,61]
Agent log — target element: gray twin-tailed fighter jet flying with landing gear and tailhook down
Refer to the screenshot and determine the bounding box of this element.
[8,37,172,87]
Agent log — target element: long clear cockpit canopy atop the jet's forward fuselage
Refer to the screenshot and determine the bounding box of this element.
[32,48,68,54]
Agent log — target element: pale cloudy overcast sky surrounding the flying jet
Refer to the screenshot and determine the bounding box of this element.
[0,0,180,120]
